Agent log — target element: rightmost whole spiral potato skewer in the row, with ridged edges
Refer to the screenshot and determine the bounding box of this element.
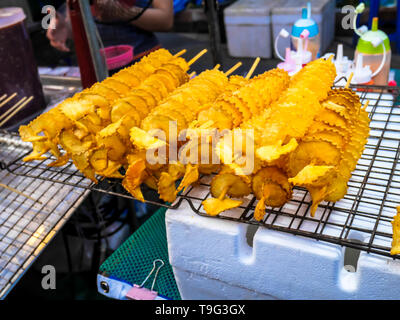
[288,88,370,215]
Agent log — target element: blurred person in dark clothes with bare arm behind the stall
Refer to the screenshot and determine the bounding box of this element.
[46,0,174,60]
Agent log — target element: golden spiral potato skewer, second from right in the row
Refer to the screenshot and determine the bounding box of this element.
[206,59,336,220]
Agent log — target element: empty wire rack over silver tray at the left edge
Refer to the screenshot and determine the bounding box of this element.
[0,131,89,299]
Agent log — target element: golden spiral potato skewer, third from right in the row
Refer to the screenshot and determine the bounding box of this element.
[203,69,296,215]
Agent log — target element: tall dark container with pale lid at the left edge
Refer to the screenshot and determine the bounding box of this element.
[0,7,46,130]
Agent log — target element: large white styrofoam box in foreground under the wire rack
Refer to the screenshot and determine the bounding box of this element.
[166,202,400,300]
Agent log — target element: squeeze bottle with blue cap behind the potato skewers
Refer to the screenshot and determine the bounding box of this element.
[291,2,320,60]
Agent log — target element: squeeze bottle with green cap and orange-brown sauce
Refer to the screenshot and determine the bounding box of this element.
[354,4,392,86]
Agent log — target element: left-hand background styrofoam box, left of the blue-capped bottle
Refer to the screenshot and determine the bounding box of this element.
[224,0,272,58]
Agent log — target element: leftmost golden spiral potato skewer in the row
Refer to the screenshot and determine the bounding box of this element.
[19,49,183,166]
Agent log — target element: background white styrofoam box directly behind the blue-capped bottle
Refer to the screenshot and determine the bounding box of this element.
[271,0,336,57]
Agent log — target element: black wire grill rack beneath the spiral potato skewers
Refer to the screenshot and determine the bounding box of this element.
[2,86,400,258]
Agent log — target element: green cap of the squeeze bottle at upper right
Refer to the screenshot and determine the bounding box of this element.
[356,17,390,54]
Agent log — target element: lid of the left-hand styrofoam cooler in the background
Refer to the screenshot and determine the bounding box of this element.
[224,0,274,17]
